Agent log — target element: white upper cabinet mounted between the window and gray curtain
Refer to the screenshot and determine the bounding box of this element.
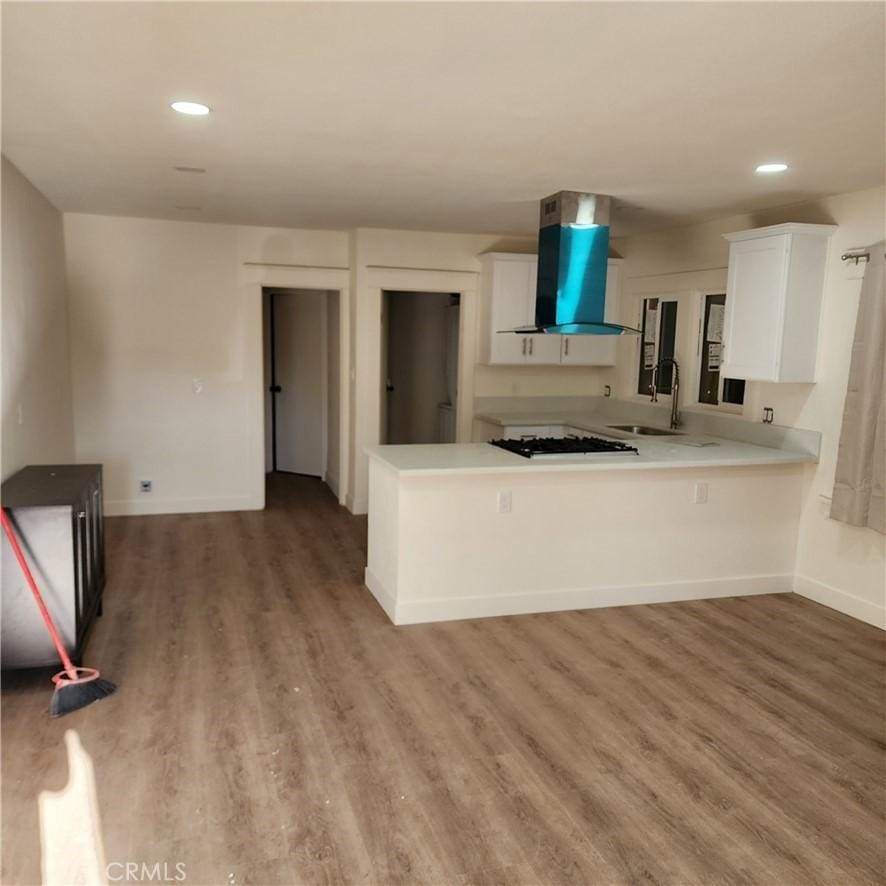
[720,224,835,382]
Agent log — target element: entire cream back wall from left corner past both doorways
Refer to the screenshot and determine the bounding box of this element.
[65,214,559,514]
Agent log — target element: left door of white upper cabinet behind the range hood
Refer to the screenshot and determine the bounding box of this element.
[489,260,535,364]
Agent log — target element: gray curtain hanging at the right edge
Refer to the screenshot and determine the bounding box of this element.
[831,242,886,533]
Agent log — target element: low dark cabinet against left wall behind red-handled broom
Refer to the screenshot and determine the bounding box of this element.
[0,465,105,668]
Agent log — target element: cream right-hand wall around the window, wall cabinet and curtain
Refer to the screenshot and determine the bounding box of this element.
[616,188,886,626]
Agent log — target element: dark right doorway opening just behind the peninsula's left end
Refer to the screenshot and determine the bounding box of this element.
[381,290,460,444]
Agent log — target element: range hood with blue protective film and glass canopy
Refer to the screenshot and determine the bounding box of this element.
[514,191,640,335]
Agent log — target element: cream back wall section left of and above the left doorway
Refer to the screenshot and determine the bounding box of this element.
[64,215,347,514]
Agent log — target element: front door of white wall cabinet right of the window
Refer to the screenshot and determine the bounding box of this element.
[720,234,790,381]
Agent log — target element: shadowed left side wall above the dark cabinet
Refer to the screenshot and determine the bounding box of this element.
[0,157,74,479]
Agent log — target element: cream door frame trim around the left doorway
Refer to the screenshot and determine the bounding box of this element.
[246,262,351,509]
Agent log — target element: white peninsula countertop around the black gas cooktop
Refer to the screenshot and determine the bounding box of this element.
[366,438,816,476]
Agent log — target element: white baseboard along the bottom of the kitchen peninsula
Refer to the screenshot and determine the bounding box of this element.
[366,569,793,625]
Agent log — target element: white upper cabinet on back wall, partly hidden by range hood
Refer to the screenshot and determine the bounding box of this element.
[480,252,621,366]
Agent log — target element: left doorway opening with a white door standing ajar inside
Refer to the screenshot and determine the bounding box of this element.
[262,288,340,485]
